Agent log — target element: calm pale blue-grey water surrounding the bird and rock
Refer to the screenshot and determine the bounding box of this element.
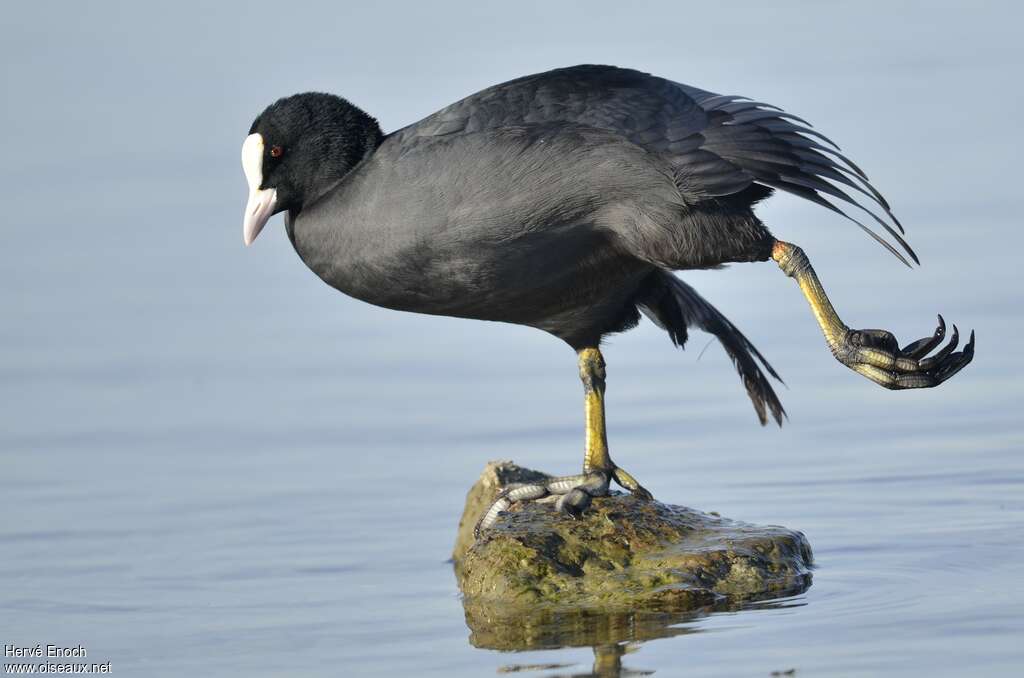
[0,3,1024,677]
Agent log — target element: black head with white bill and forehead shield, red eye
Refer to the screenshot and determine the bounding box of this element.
[242,92,383,245]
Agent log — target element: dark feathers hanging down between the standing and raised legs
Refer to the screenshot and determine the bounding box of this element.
[637,270,785,426]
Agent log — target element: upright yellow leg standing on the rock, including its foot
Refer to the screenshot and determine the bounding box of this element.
[474,346,651,537]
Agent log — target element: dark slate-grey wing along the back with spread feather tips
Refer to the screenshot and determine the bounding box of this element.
[396,66,918,263]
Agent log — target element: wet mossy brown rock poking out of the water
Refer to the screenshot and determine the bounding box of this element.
[453,462,812,614]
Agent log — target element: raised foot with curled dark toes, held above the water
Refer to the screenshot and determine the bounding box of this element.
[831,315,974,390]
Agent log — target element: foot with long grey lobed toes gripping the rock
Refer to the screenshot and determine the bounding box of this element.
[473,466,653,539]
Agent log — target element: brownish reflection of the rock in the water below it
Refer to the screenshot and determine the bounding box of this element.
[463,594,810,678]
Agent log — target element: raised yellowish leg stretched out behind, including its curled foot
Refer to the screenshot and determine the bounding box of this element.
[771,241,974,389]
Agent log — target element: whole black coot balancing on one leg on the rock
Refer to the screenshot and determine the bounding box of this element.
[242,66,974,527]
